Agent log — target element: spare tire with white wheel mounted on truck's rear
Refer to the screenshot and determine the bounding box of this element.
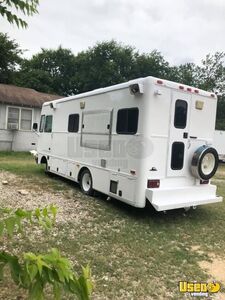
[191,145,219,180]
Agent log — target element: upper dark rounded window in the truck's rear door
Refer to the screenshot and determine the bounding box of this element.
[174,100,188,129]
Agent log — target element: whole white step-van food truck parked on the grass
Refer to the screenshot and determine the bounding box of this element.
[37,77,222,211]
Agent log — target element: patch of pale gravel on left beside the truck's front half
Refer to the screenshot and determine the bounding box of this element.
[0,172,88,223]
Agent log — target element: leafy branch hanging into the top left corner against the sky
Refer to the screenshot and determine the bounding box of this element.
[0,0,39,28]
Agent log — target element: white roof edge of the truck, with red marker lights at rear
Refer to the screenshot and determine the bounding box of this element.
[43,76,217,106]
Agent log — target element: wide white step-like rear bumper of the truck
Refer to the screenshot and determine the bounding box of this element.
[145,184,223,211]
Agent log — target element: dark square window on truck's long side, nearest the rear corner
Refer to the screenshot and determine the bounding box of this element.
[116,107,139,134]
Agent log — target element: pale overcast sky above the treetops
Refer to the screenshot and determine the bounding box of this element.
[0,0,225,64]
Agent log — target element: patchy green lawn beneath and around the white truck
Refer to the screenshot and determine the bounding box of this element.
[0,153,225,299]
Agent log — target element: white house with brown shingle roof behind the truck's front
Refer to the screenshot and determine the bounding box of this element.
[0,84,60,151]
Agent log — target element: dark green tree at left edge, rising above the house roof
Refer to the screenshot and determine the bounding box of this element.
[0,33,23,84]
